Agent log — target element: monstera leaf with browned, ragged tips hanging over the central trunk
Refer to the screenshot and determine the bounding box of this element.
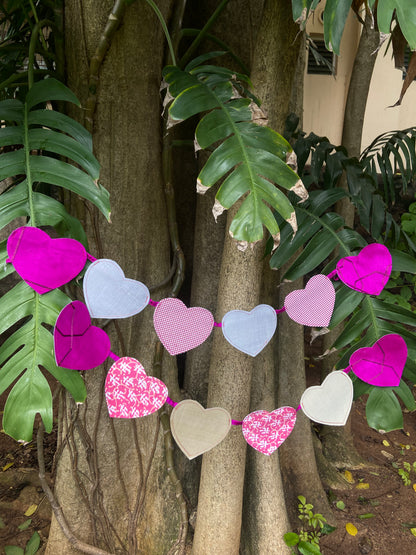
[163,65,307,242]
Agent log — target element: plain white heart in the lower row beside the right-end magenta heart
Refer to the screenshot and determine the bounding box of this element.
[300,370,353,426]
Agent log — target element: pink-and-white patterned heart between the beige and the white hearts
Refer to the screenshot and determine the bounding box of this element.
[242,407,296,455]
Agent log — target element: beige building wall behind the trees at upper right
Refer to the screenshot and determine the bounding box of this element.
[303,5,416,149]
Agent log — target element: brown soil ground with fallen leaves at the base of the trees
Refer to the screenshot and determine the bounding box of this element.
[0,382,416,555]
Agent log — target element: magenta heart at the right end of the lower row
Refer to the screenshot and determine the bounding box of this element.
[350,333,407,387]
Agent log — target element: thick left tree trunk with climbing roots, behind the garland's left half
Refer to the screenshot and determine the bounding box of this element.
[47,0,181,555]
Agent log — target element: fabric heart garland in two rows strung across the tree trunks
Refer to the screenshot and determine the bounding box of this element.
[6,227,407,459]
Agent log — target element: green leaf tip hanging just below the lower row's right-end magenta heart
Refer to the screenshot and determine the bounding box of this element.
[365,387,403,432]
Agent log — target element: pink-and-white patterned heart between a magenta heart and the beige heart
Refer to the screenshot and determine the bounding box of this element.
[105,357,168,418]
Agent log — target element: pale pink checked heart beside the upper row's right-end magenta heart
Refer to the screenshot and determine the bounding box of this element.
[284,274,335,328]
